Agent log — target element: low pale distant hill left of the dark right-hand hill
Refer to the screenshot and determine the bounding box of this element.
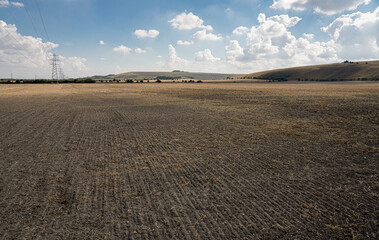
[107,71,241,80]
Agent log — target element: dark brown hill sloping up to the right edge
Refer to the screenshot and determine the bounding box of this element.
[240,61,379,81]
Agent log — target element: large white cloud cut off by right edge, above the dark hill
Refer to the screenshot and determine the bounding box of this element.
[322,7,379,60]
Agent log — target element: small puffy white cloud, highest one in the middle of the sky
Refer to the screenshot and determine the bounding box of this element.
[168,12,213,31]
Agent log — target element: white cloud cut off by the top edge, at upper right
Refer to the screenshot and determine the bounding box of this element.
[271,0,371,15]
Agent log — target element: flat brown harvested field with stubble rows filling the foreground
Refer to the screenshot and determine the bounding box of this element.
[0,83,379,239]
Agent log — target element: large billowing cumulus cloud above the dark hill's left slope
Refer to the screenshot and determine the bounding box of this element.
[225,14,338,70]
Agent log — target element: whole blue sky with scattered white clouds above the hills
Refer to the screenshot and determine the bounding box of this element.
[0,0,379,78]
